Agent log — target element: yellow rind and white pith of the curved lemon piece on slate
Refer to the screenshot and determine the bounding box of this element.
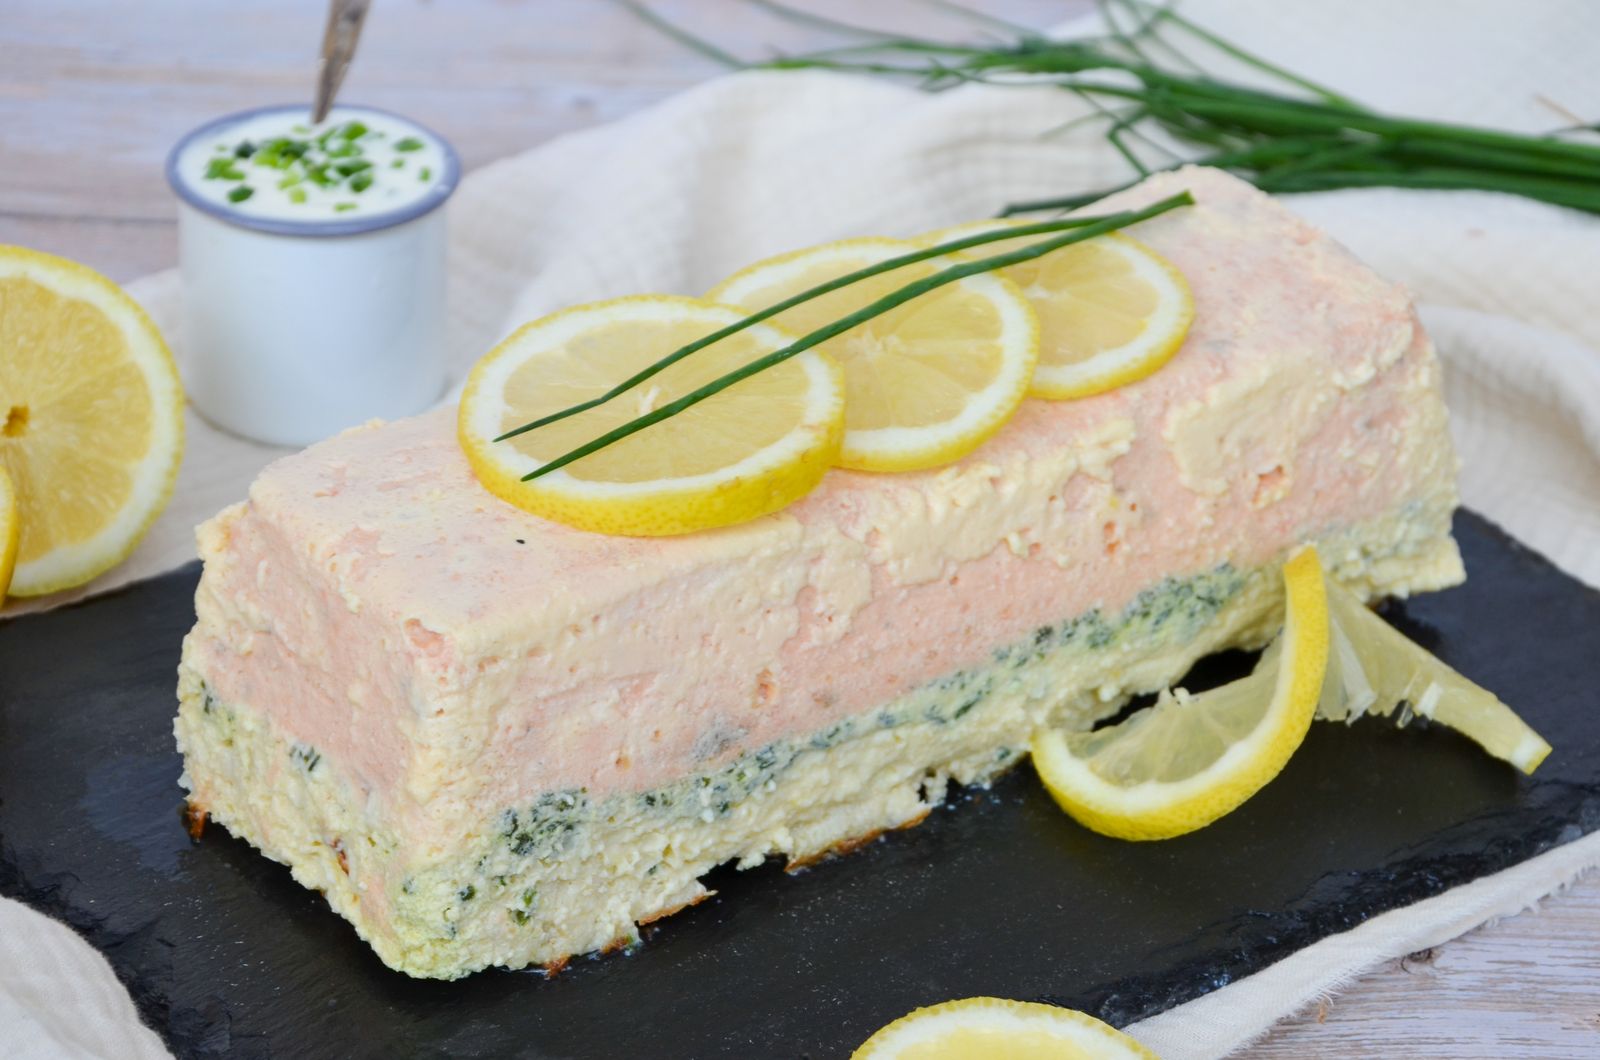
[1032,548,1328,839]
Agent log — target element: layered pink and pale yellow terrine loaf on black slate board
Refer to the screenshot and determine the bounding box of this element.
[176,168,1462,977]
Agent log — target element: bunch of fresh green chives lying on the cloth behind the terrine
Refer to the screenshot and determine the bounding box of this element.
[618,0,1600,213]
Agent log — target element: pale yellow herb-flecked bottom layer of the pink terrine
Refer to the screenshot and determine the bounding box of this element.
[176,509,1461,978]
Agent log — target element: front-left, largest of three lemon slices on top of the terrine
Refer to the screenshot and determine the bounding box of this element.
[458,296,845,536]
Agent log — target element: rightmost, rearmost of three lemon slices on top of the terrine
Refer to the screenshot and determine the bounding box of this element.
[918,219,1195,400]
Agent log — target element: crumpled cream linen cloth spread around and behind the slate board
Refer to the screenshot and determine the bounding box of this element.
[0,0,1600,1060]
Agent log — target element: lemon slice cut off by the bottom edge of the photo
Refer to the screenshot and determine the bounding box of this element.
[851,998,1155,1060]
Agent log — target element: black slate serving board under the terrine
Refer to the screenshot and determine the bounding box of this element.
[0,512,1600,1058]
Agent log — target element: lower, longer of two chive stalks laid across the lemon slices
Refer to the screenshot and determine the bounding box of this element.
[508,192,1194,482]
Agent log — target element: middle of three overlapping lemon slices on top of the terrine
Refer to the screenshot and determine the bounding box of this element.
[706,239,1038,471]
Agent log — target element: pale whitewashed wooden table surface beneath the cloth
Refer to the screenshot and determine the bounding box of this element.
[0,0,1600,1058]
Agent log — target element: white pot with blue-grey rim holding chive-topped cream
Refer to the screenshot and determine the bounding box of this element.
[166,106,461,445]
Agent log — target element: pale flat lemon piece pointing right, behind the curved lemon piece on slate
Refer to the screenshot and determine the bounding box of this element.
[1317,581,1550,773]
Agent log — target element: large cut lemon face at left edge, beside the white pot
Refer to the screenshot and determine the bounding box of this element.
[0,247,184,596]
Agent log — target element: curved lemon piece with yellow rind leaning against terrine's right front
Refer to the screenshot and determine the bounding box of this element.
[1032,548,1328,839]
